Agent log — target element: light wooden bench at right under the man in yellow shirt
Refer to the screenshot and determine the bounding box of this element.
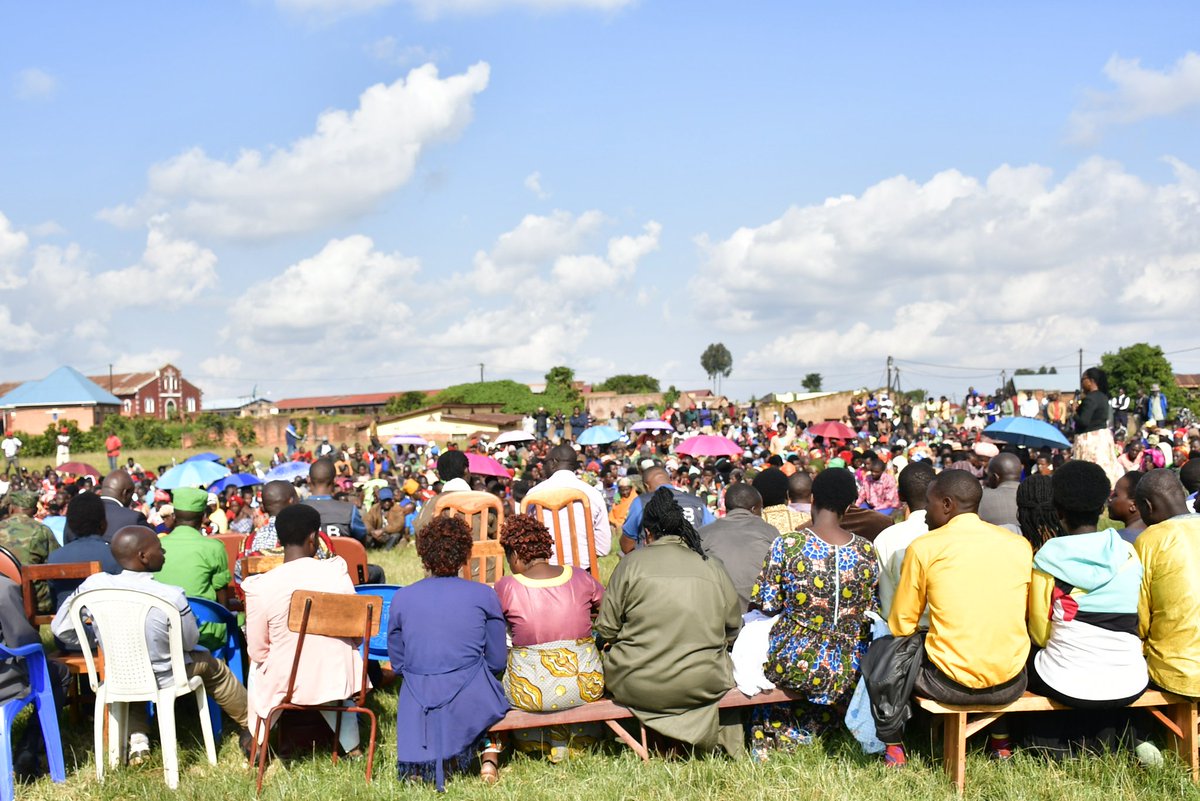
[916,689,1200,794]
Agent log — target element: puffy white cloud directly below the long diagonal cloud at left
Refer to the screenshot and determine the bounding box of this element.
[226,235,419,350]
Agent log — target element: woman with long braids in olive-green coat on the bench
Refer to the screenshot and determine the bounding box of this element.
[595,487,745,754]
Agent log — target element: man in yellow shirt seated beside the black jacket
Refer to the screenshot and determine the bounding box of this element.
[878,470,1033,766]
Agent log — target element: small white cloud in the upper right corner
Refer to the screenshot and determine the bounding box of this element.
[1068,50,1200,144]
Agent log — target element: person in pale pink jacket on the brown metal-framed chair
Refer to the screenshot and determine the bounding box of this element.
[241,504,362,755]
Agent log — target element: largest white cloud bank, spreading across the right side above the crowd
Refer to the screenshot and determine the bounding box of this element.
[691,159,1200,380]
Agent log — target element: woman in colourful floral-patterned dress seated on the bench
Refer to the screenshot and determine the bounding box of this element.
[750,468,878,752]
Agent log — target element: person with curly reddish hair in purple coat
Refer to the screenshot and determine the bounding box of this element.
[388,517,509,791]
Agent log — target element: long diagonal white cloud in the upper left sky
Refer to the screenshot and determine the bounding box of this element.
[100,62,488,240]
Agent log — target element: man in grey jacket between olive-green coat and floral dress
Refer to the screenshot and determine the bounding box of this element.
[698,482,779,614]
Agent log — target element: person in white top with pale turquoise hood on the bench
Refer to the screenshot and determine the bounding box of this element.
[1026,460,1162,761]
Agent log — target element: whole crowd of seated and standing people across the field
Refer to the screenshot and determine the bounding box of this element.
[0,368,1200,789]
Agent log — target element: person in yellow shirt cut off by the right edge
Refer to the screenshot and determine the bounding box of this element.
[1133,468,1200,698]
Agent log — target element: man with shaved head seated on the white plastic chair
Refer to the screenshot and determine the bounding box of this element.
[50,526,251,764]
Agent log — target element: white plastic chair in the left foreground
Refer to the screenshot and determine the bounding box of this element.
[70,589,217,790]
